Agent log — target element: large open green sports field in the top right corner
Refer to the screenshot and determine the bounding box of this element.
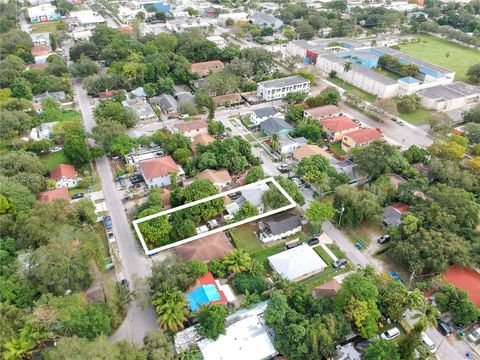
[400,35,480,81]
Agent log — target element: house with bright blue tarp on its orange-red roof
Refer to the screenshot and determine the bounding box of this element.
[187,272,228,312]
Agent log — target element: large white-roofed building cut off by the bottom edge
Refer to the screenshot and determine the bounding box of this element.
[197,302,277,360]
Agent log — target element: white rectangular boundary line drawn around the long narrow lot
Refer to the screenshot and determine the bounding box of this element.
[132,177,297,255]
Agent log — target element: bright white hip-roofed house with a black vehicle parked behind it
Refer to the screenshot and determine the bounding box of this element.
[268,244,327,281]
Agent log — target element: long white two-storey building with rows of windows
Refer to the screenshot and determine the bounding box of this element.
[257,75,310,101]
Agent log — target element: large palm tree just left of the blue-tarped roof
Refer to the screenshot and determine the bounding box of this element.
[152,287,188,332]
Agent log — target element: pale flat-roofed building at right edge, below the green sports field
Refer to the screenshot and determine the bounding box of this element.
[418,82,480,111]
